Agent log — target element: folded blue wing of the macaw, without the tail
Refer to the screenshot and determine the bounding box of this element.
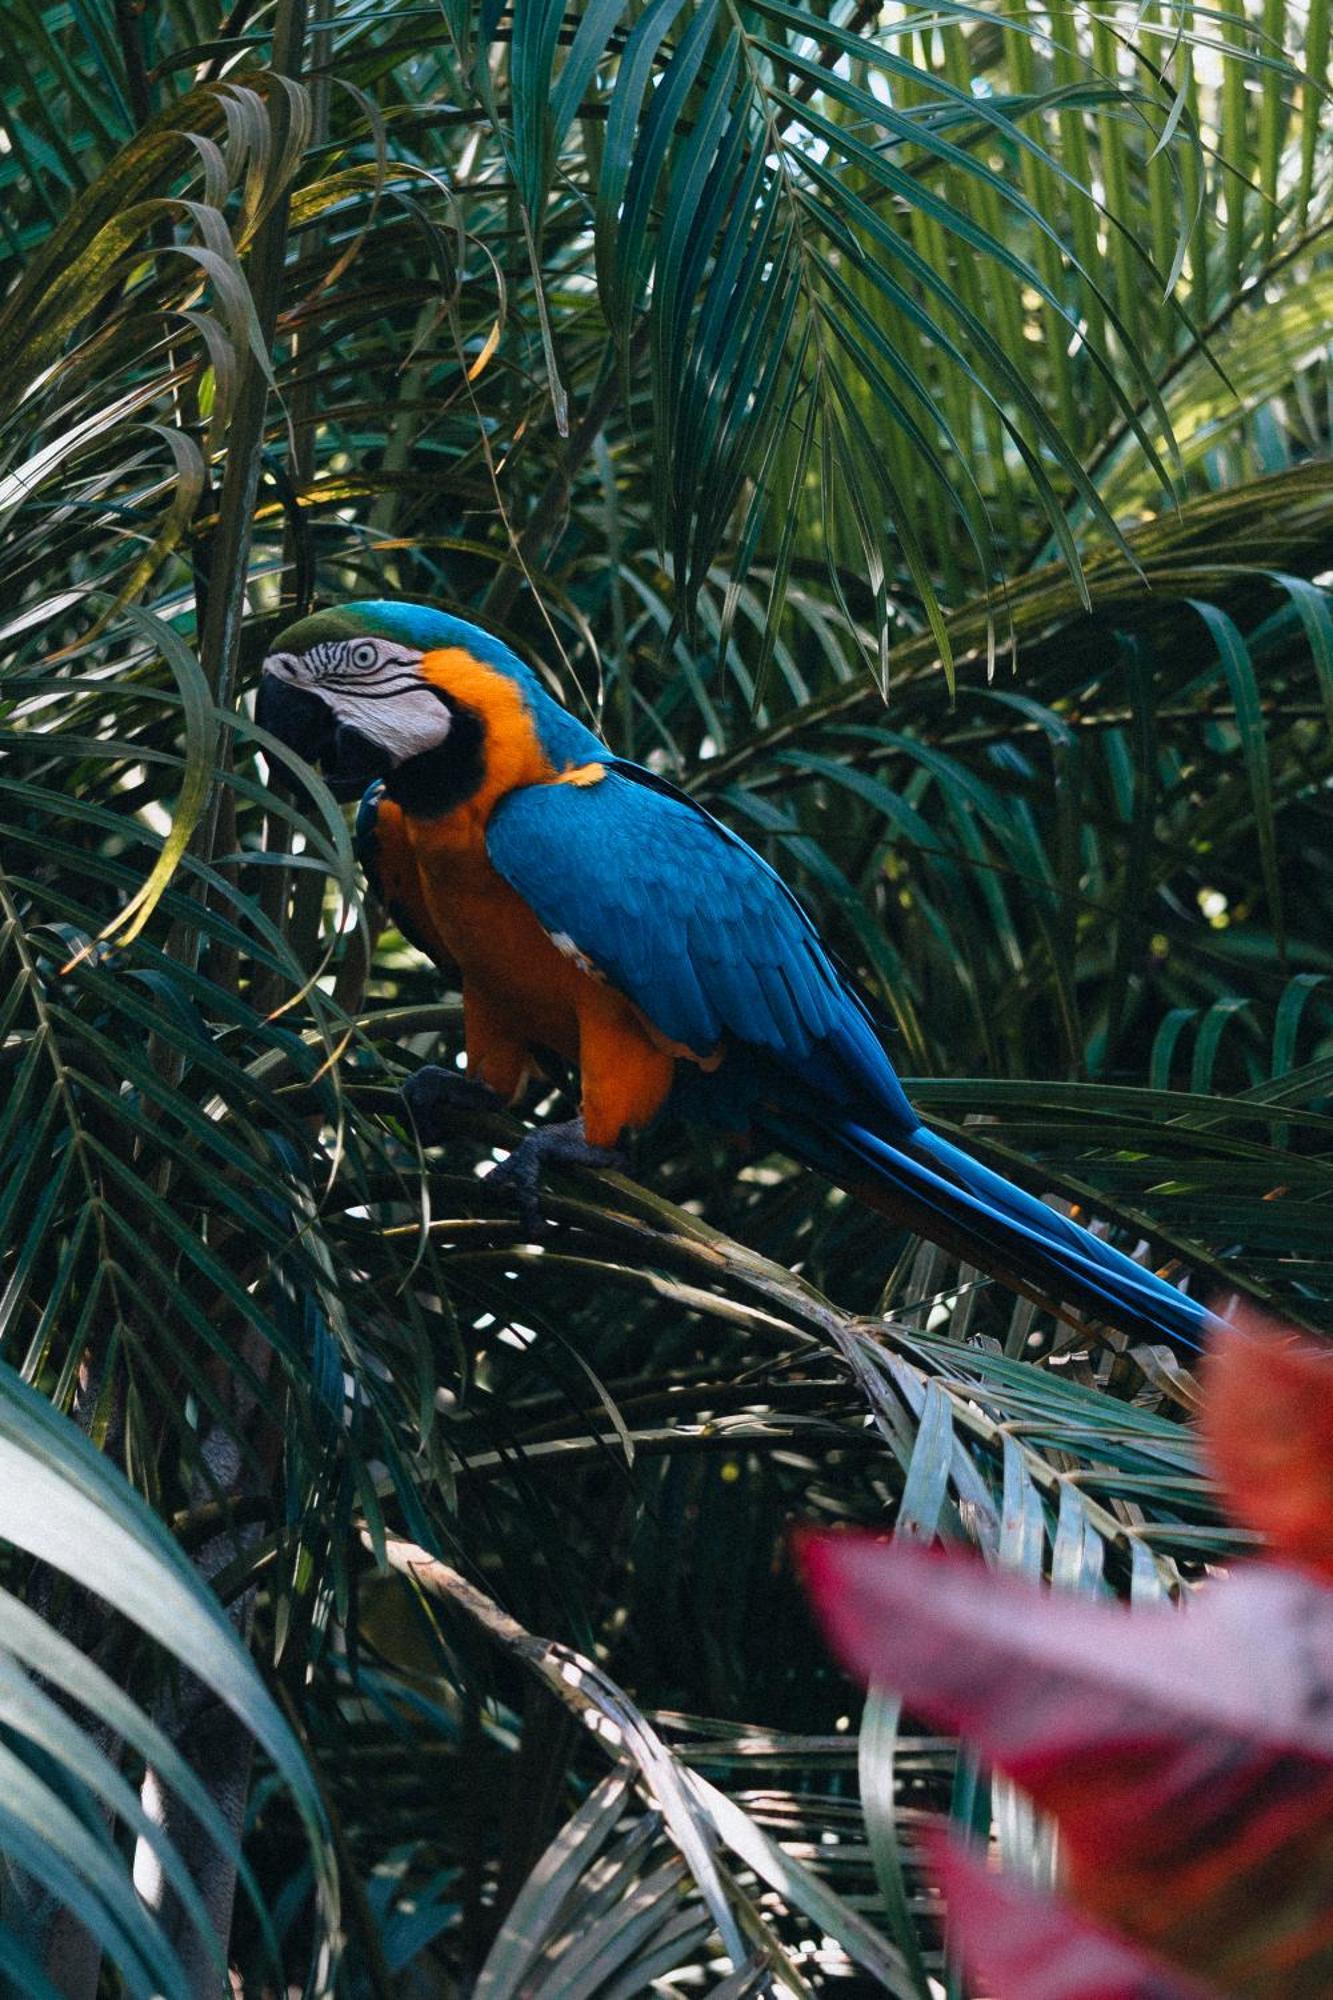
[486,762,917,1126]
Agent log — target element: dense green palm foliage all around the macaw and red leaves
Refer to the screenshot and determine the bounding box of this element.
[0,0,1333,2000]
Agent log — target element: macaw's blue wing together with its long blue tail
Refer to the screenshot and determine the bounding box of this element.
[486,764,1205,1346]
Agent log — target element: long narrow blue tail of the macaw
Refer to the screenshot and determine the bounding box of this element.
[763,1106,1209,1348]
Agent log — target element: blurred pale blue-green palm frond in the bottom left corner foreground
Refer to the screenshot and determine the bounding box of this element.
[0,1368,336,2000]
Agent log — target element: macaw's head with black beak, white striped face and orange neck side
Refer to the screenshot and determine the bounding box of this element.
[256,598,600,814]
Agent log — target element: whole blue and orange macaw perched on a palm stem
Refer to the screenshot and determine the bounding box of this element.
[258,600,1207,1346]
